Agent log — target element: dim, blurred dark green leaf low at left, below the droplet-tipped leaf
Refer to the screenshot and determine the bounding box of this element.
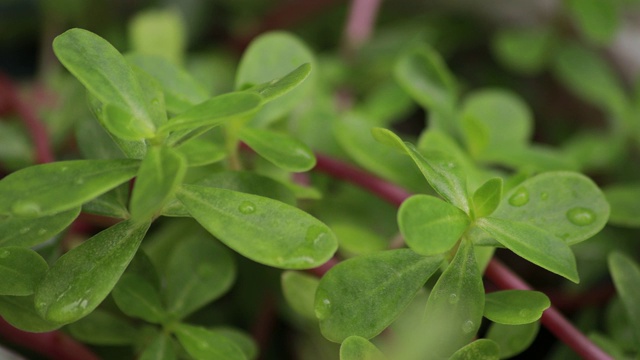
[66,309,138,346]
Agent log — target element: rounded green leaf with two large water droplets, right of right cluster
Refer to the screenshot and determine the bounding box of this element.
[492,171,609,245]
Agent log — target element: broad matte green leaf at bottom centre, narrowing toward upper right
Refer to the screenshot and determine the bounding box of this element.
[315,249,442,342]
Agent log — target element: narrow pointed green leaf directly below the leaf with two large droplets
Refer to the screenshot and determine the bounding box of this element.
[476,217,580,283]
